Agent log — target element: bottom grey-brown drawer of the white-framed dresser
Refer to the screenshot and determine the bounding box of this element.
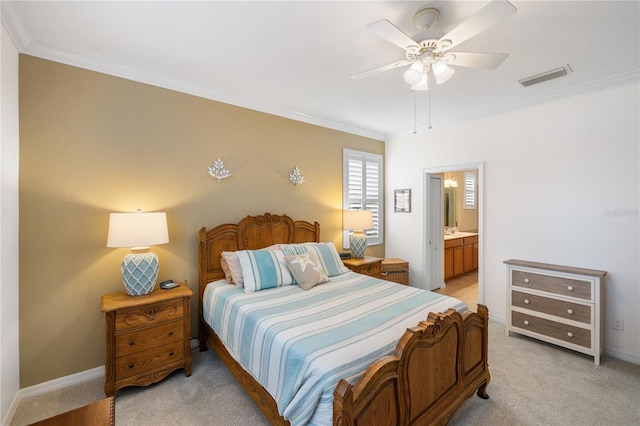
[511,311,591,348]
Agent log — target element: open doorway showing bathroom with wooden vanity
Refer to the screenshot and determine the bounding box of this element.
[423,163,484,310]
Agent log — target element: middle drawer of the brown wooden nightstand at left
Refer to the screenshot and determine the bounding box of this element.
[116,321,184,356]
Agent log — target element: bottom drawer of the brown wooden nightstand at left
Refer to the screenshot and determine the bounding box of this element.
[116,341,184,380]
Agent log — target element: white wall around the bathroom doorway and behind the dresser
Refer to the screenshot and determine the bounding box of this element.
[385,84,640,363]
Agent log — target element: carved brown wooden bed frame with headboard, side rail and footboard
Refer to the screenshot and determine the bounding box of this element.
[198,213,490,426]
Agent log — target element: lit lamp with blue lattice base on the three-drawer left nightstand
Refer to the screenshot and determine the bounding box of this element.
[107,210,169,296]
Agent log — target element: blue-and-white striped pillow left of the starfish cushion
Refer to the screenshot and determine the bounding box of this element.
[234,250,294,293]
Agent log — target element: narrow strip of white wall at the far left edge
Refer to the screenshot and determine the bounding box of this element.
[0,20,20,424]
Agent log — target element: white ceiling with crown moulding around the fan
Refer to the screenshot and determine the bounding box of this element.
[2,0,640,139]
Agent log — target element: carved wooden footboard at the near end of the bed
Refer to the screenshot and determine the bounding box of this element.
[333,305,490,426]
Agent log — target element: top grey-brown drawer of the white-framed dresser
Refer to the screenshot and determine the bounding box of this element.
[511,270,592,300]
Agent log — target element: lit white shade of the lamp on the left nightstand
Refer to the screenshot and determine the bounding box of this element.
[107,211,169,247]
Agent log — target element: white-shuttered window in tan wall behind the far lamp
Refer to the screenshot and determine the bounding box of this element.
[342,149,383,248]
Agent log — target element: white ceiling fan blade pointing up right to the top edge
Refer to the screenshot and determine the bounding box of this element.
[440,0,518,50]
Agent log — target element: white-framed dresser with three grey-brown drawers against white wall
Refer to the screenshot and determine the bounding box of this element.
[504,259,607,365]
